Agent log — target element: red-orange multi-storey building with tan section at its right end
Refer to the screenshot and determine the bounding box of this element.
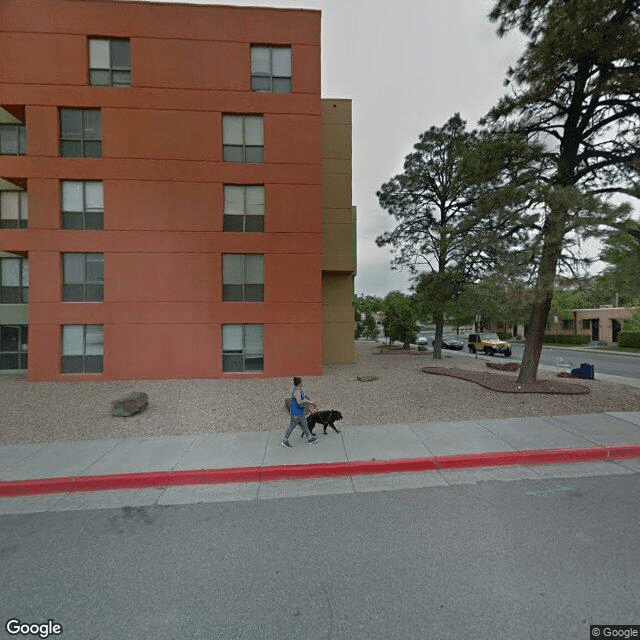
[0,0,356,380]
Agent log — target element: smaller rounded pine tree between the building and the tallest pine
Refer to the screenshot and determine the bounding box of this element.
[376,114,530,358]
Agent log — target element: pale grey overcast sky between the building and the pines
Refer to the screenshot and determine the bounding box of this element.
[151,0,524,296]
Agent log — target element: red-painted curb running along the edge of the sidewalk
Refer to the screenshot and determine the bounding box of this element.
[0,444,640,497]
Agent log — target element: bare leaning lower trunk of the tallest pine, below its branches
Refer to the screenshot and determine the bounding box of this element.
[518,211,566,383]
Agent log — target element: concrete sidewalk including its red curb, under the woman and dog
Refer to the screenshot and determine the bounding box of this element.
[0,411,640,502]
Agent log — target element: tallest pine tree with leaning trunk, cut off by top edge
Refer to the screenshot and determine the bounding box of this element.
[484,0,640,382]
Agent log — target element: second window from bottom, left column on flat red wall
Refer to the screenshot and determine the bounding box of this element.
[62,253,104,302]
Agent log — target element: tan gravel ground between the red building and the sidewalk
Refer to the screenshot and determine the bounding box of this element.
[0,342,640,444]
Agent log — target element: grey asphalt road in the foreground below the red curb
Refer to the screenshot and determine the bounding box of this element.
[0,473,640,640]
